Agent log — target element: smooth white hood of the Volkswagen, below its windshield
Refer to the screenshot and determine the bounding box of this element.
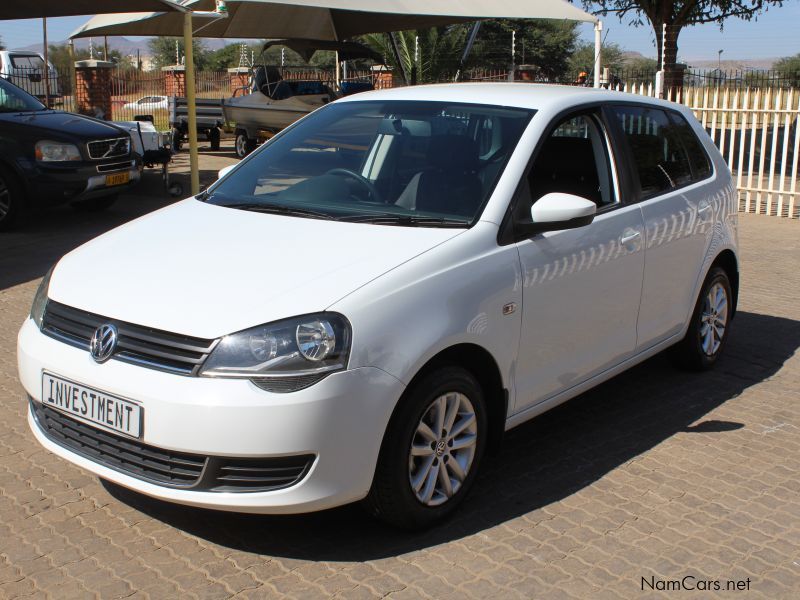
[49,199,464,338]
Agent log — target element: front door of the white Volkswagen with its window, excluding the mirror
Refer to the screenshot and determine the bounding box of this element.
[512,110,644,410]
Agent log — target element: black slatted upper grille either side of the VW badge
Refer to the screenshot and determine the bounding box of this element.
[42,300,216,375]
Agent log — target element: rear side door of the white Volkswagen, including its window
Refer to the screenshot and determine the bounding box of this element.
[610,104,714,350]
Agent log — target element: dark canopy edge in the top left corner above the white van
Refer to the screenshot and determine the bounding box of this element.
[0,0,182,21]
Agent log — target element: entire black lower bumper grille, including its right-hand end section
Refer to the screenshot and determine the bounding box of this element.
[30,400,314,493]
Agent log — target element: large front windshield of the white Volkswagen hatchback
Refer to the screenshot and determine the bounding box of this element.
[204,101,533,227]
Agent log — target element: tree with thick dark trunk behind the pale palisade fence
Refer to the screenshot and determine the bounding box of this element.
[582,0,783,85]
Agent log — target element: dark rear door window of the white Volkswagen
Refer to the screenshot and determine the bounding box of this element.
[612,106,692,198]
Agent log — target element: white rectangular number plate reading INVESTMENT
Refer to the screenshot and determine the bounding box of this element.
[42,373,142,438]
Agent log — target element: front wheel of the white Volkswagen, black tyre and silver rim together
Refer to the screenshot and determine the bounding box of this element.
[366,366,488,529]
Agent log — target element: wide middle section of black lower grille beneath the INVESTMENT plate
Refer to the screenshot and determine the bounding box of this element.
[31,402,207,487]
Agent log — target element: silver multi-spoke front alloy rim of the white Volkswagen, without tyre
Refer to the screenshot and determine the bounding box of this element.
[408,392,478,506]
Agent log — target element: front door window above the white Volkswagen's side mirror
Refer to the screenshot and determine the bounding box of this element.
[520,114,616,213]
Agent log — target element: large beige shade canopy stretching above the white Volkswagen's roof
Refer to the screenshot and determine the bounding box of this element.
[70,0,597,40]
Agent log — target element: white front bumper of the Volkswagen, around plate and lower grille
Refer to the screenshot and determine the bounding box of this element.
[17,319,404,513]
